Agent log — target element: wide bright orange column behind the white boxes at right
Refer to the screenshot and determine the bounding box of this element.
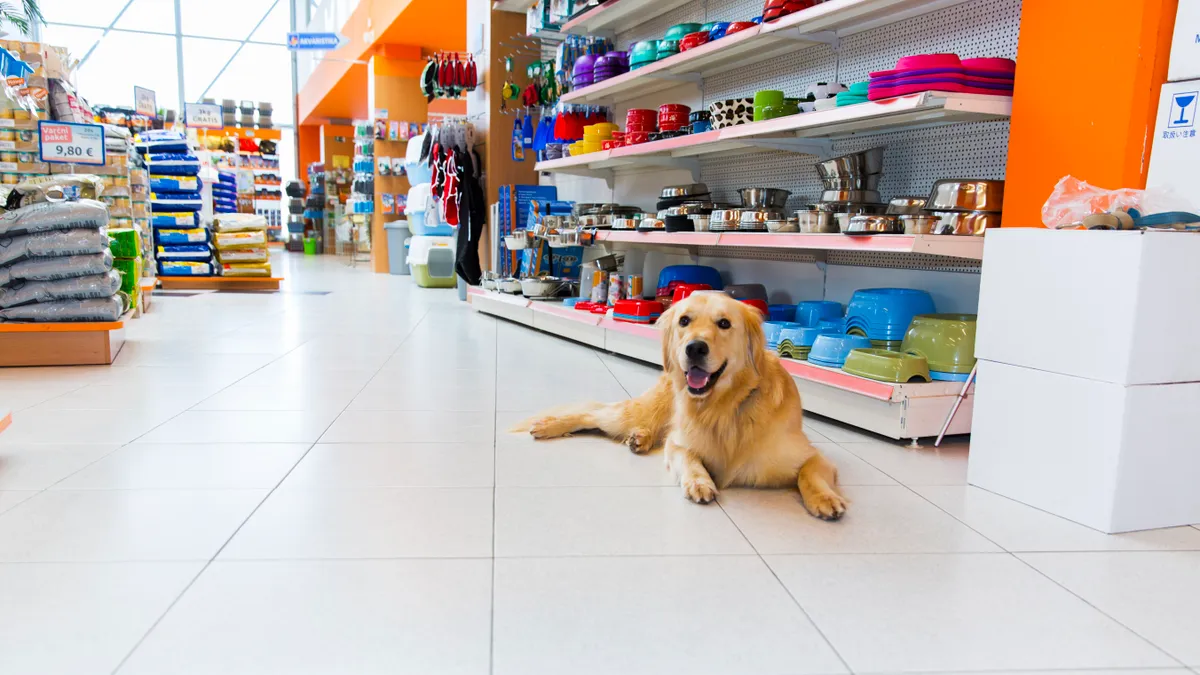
[1004,0,1178,227]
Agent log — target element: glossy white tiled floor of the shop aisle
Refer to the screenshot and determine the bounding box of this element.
[0,256,1200,675]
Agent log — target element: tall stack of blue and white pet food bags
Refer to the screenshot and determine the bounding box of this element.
[137,131,216,276]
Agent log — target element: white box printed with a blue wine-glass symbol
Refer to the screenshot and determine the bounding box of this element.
[1146,76,1200,214]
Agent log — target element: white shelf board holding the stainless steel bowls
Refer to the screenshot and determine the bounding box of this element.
[596,229,983,261]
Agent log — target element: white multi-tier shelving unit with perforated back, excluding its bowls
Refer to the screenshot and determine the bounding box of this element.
[470,0,1021,440]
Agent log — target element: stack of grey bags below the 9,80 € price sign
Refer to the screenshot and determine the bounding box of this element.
[0,192,128,322]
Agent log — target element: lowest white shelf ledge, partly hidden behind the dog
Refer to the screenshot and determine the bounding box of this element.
[469,287,974,438]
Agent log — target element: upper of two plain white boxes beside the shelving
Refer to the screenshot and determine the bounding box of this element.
[976,227,1200,381]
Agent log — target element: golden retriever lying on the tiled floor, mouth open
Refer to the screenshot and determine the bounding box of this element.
[517,292,847,520]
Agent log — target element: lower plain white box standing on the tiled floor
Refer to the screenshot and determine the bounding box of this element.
[968,357,1200,533]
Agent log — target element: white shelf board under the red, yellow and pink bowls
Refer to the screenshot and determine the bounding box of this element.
[535,91,1013,178]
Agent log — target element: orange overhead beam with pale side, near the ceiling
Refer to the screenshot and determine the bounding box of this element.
[298,0,467,124]
